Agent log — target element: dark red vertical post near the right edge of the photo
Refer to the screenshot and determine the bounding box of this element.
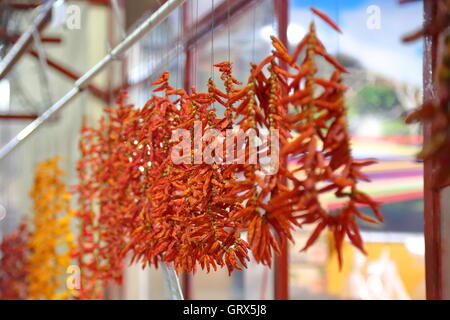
[423,0,442,300]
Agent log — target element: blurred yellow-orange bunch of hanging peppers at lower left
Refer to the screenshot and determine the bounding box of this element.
[27,156,74,300]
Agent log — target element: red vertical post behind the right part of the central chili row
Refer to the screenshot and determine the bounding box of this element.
[274,0,289,300]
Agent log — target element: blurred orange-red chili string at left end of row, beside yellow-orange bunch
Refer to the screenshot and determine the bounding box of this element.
[73,92,146,299]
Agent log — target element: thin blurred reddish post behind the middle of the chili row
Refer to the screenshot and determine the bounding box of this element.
[182,2,194,300]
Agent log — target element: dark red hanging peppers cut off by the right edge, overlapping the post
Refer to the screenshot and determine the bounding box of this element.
[403,0,450,187]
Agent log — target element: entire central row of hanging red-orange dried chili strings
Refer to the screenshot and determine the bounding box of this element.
[77,9,382,295]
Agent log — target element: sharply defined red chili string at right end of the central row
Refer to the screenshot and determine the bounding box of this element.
[269,10,383,264]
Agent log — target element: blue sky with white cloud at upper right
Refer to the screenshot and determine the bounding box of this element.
[290,0,423,85]
